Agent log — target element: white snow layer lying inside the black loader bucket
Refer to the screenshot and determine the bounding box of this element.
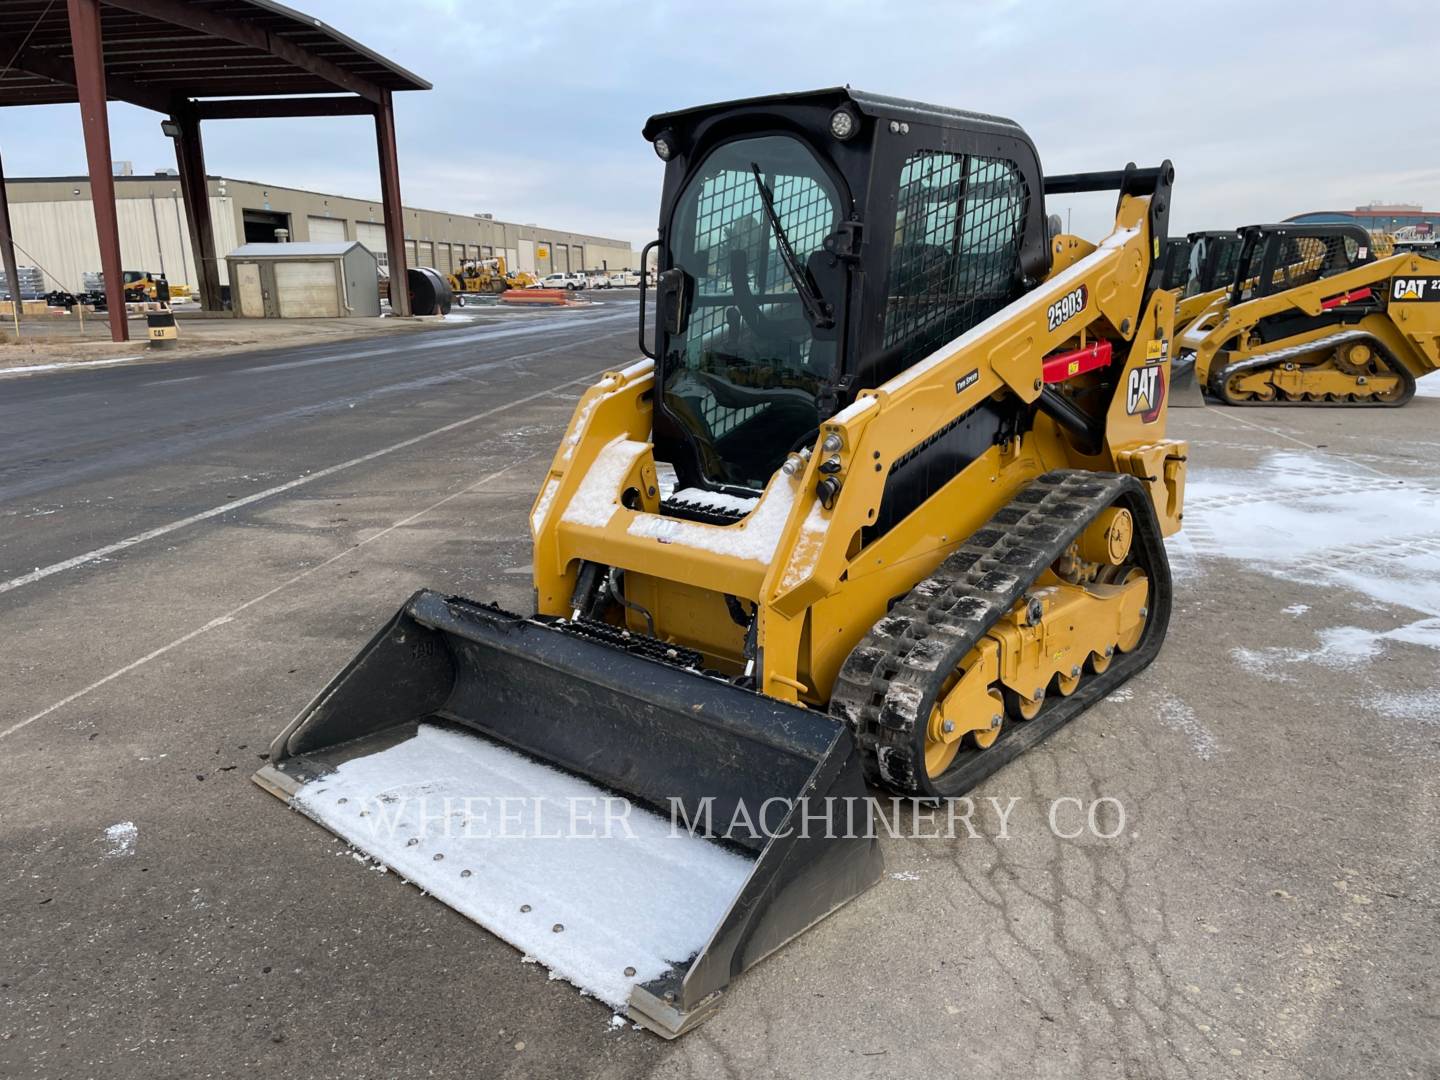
[294,724,753,1009]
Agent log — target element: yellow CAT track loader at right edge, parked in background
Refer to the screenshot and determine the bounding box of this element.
[1176,225,1440,406]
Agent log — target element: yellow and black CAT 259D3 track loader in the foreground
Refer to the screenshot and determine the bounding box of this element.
[256,89,1185,1037]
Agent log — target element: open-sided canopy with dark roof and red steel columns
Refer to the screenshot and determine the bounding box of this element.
[0,0,431,341]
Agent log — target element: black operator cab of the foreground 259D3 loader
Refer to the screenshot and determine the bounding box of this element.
[641,89,1050,495]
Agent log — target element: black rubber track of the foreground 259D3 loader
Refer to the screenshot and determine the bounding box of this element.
[829,469,1171,799]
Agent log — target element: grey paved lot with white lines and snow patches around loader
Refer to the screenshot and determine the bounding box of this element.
[0,316,1440,1079]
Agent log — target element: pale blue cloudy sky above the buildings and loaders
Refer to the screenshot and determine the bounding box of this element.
[0,0,1440,246]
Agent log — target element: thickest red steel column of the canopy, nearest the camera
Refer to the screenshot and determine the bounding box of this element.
[66,0,130,341]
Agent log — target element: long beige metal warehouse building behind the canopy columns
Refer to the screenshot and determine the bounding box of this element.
[4,174,638,292]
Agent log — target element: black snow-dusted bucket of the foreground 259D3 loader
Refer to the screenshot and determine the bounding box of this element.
[255,590,881,1038]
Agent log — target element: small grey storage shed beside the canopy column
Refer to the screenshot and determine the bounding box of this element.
[225,240,380,318]
